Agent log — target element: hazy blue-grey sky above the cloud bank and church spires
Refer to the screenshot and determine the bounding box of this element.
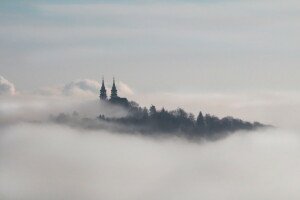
[0,0,300,93]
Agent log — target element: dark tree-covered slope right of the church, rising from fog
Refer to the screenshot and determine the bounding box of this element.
[98,102,268,139]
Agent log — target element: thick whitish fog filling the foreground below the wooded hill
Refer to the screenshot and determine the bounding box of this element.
[0,123,300,200]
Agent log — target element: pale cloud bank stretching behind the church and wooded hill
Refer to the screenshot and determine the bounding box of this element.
[0,75,300,130]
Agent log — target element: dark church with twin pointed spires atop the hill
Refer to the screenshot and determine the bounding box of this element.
[99,78,129,107]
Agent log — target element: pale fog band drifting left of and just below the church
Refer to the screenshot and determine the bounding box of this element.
[0,95,127,125]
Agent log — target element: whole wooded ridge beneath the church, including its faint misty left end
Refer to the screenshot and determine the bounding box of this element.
[50,90,271,140]
